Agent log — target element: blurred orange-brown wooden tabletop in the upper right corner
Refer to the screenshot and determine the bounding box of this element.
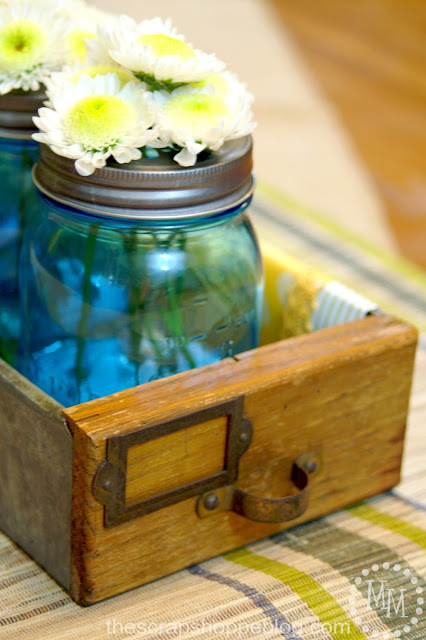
[269,0,426,267]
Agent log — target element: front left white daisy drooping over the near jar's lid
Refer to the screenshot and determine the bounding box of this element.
[33,73,161,176]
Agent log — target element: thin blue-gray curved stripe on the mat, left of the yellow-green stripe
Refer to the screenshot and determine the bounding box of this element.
[188,565,303,640]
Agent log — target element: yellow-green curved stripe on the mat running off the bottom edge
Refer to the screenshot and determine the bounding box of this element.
[224,549,366,640]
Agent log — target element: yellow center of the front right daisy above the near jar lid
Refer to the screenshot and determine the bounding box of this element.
[164,93,229,140]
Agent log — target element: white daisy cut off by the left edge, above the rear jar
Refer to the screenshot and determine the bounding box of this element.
[0,0,67,94]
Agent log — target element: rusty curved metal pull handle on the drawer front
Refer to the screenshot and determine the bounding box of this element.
[197,453,319,523]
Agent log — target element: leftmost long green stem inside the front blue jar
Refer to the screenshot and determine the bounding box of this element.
[75,224,97,396]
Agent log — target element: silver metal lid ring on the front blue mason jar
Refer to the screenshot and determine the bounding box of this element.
[33,136,254,220]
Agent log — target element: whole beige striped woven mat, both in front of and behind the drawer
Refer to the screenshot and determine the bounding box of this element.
[0,0,426,640]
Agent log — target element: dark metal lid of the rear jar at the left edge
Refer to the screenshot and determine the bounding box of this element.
[0,90,46,140]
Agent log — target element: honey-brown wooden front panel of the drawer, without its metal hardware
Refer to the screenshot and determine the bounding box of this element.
[65,317,416,605]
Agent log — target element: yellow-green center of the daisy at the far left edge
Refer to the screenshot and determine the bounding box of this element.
[0,20,46,72]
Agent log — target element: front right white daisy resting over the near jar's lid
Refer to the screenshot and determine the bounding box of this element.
[152,74,256,167]
